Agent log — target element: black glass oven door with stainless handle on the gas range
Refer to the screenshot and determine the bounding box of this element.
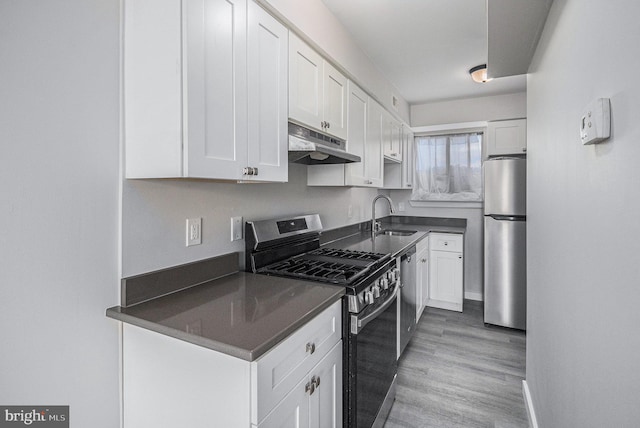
[345,291,398,428]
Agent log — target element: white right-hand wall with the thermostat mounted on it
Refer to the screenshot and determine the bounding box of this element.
[526,0,640,428]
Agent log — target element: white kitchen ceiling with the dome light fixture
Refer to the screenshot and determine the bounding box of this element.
[322,0,532,104]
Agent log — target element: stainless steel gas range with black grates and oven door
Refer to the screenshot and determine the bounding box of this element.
[245,214,400,428]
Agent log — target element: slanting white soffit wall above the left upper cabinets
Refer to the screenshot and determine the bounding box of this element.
[258,0,409,123]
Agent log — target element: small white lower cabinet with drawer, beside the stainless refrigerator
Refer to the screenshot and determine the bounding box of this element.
[427,233,463,312]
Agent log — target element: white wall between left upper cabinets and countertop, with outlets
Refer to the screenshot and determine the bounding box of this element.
[122,164,388,277]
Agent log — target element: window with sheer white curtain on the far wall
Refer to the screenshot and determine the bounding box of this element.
[411,132,482,201]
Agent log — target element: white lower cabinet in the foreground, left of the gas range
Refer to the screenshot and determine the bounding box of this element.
[122,301,342,428]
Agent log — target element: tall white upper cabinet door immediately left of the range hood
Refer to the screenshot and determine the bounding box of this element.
[246,1,288,181]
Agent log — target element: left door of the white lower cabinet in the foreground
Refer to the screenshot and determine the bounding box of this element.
[254,377,310,428]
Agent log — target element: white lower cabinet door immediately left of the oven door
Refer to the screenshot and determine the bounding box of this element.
[309,341,342,428]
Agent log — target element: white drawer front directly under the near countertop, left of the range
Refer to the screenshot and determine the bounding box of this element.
[251,301,342,424]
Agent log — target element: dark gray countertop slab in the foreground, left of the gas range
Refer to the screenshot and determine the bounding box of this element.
[107,272,344,361]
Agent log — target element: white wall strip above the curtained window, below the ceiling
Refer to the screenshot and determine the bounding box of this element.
[411,92,527,127]
